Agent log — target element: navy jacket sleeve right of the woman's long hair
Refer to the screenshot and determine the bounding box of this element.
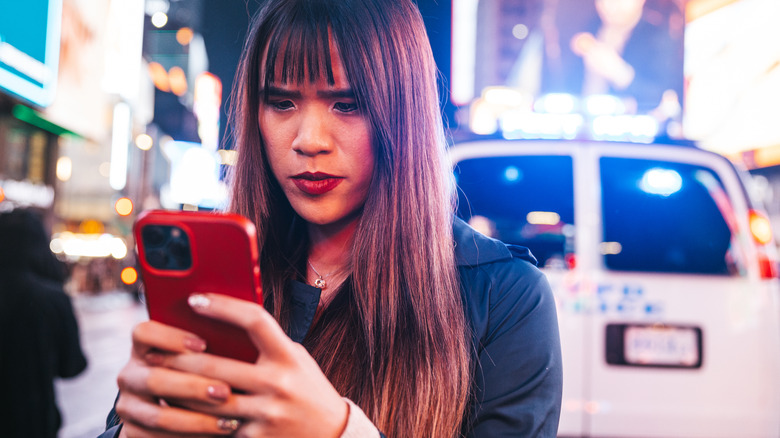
[465,259,563,438]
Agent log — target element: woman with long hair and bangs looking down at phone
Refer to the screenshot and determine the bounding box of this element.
[106,0,561,437]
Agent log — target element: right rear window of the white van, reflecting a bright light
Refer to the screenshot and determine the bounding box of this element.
[600,157,741,275]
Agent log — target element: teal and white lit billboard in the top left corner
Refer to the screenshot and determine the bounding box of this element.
[0,0,62,107]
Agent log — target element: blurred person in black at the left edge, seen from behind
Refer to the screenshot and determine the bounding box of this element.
[0,209,87,438]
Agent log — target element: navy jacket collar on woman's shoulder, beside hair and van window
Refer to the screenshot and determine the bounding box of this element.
[452,217,536,267]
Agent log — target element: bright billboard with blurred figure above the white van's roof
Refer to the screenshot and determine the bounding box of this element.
[451,0,685,136]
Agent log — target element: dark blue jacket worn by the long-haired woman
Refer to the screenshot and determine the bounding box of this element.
[101,219,563,438]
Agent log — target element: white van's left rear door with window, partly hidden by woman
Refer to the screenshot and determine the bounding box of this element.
[454,148,590,436]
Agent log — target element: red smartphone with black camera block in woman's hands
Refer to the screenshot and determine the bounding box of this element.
[133,210,263,362]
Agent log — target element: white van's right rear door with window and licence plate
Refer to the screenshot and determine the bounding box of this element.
[583,156,780,438]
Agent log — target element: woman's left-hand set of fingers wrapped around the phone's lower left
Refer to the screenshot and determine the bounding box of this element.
[116,321,239,437]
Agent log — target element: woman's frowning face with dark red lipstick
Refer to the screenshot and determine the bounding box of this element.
[258,41,375,229]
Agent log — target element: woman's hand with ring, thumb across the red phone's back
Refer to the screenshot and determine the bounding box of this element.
[147,294,349,438]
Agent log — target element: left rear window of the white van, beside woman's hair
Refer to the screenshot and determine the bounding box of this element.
[455,156,574,268]
